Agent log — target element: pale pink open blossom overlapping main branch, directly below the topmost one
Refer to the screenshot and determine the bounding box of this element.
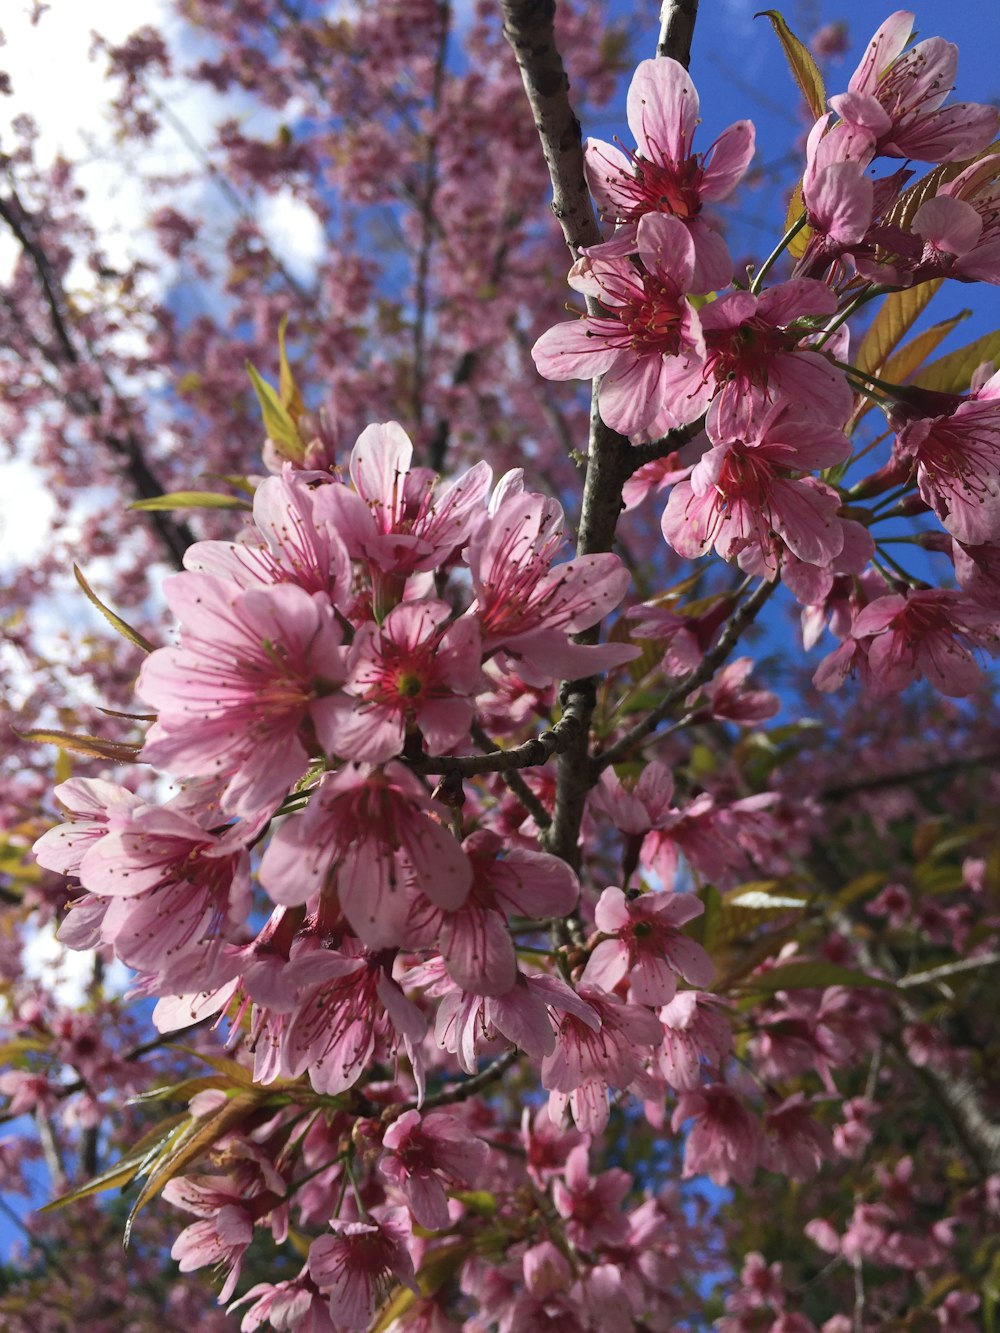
[532,213,714,435]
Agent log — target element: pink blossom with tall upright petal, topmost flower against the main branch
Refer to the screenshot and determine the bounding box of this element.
[584,57,755,292]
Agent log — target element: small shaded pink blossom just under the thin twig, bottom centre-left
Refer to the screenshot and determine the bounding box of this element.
[379,1110,489,1232]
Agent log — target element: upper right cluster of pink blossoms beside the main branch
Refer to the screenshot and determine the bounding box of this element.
[533,18,1000,696]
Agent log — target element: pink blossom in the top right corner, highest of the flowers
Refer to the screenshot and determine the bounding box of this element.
[829,9,1000,163]
